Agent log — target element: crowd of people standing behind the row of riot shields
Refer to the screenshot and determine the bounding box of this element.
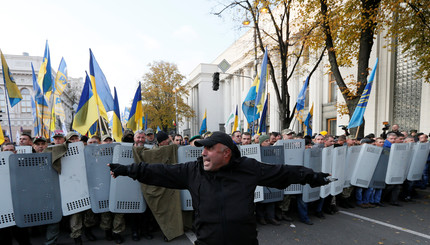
[0,125,430,245]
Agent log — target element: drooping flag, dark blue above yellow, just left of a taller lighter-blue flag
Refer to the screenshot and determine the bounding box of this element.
[72,74,98,135]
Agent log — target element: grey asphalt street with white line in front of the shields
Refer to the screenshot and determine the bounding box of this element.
[21,188,430,245]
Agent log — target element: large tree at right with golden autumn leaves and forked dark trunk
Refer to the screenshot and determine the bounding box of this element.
[299,0,430,136]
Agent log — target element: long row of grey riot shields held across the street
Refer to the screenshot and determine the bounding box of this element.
[0,140,430,228]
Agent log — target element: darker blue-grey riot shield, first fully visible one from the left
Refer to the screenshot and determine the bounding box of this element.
[9,153,62,227]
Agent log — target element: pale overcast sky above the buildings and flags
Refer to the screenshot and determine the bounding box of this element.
[0,0,245,111]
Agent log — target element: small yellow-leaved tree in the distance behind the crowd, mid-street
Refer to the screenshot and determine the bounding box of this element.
[142,61,194,132]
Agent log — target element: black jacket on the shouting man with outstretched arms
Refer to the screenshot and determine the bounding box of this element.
[129,157,314,245]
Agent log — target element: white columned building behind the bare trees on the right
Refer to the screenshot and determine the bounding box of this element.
[180,19,430,136]
